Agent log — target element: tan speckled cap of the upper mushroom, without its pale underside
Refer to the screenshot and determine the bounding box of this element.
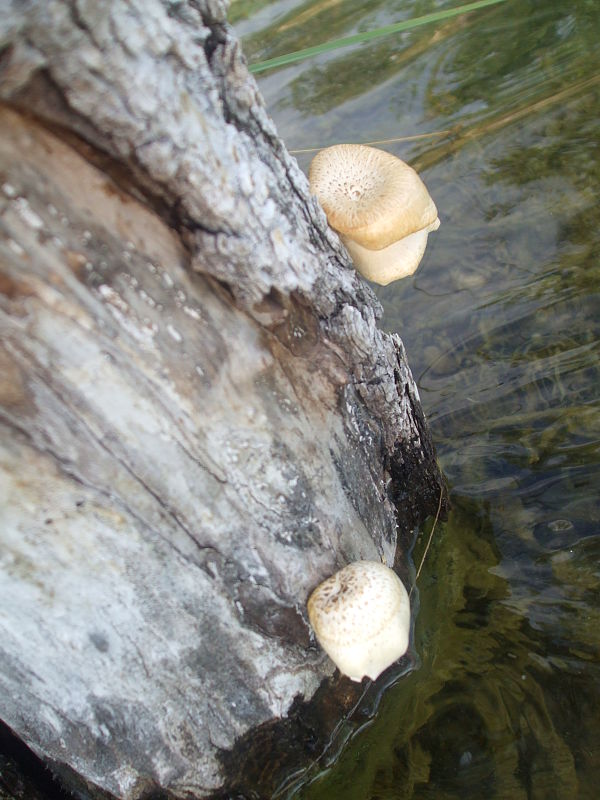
[309,144,438,250]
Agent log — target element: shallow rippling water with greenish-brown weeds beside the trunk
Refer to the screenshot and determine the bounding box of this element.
[231,0,600,800]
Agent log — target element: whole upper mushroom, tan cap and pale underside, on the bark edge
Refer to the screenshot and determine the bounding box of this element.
[308,144,440,286]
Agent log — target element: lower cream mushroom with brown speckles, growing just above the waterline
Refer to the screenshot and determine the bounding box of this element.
[308,561,410,681]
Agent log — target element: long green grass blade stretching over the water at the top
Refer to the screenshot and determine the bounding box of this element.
[248,0,506,73]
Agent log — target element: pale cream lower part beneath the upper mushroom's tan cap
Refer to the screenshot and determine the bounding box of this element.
[341,219,440,286]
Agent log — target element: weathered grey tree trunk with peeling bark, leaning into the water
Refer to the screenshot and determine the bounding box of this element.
[0,0,444,798]
